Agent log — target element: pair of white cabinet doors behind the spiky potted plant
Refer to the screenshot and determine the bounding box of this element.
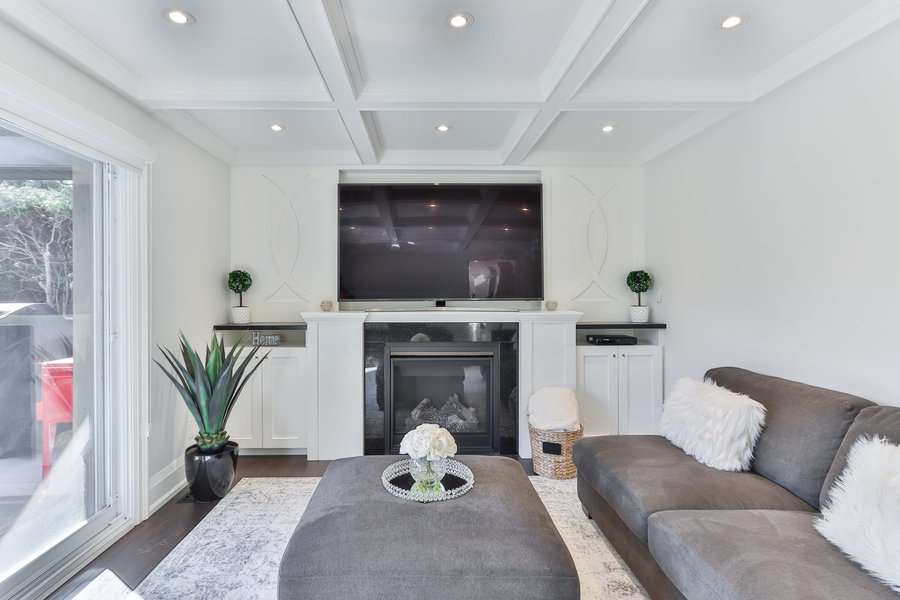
[227,348,312,449]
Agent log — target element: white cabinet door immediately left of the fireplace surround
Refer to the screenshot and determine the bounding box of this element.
[257,348,308,448]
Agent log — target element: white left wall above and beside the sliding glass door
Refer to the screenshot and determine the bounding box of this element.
[0,21,230,506]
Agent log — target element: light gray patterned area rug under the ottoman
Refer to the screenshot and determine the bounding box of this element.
[93,477,647,600]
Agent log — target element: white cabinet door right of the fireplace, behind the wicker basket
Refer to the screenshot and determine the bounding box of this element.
[576,346,619,436]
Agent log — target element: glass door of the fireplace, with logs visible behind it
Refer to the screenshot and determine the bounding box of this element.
[388,353,494,452]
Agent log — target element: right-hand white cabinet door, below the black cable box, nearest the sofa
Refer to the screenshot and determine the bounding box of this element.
[618,346,662,434]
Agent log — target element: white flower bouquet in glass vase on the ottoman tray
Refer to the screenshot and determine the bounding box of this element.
[400,423,456,494]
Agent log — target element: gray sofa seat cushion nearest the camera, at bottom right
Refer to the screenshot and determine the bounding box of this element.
[650,510,897,600]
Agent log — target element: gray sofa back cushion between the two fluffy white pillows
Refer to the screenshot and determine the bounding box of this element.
[706,367,873,508]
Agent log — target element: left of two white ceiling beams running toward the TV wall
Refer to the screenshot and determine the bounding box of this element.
[287,0,381,164]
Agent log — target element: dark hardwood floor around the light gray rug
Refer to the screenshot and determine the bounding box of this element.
[50,456,534,600]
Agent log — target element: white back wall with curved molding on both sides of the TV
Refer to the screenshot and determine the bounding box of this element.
[231,167,643,321]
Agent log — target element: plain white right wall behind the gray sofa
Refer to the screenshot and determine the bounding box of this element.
[645,25,900,405]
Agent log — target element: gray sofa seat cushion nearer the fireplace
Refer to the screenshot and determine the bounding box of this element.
[573,435,813,543]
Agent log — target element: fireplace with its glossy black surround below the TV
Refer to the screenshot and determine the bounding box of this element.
[365,323,518,454]
